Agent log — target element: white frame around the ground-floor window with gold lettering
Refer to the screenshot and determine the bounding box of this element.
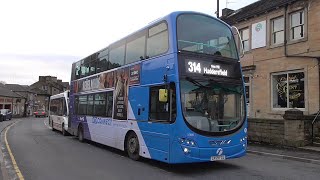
[270,69,307,111]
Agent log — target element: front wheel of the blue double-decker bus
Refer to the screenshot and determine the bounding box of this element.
[126,133,140,161]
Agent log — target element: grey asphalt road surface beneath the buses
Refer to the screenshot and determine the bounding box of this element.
[7,118,320,180]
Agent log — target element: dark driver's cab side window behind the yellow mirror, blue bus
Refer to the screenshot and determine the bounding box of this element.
[149,83,177,122]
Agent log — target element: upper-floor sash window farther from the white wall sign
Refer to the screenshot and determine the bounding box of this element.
[290,11,304,40]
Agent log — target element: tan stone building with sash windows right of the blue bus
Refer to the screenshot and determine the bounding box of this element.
[221,0,320,144]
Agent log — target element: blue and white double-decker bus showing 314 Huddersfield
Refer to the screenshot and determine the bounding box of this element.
[68,12,247,163]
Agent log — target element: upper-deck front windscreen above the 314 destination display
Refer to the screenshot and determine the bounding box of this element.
[177,14,238,59]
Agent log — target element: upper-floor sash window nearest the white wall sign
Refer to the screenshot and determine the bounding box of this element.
[271,17,284,44]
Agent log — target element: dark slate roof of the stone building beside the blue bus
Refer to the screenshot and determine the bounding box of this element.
[221,0,298,25]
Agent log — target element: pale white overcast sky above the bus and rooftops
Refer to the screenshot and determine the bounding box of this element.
[0,0,257,85]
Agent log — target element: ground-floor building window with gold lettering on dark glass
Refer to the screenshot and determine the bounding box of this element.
[272,72,305,108]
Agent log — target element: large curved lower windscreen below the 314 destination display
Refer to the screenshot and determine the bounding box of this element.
[181,80,245,132]
